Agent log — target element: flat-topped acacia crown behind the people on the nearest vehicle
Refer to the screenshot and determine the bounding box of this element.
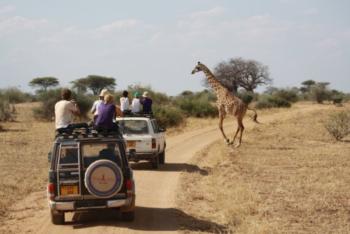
[71,75,117,95]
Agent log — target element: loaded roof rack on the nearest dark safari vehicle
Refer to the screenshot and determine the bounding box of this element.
[55,128,123,139]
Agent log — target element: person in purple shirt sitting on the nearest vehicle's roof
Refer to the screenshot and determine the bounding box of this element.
[95,94,118,131]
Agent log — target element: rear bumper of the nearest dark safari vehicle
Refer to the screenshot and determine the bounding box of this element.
[49,197,134,212]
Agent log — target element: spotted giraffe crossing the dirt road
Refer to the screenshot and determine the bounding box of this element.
[192,62,258,147]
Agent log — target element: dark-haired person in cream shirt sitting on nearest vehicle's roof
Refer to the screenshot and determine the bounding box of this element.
[55,89,88,133]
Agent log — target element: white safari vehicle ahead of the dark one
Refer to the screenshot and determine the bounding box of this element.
[116,116,166,169]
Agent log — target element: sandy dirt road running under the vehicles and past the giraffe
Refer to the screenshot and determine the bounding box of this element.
[0,103,330,234]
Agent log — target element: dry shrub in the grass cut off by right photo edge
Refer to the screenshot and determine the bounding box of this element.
[325,111,350,141]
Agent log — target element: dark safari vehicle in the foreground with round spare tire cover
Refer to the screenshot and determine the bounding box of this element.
[47,132,135,224]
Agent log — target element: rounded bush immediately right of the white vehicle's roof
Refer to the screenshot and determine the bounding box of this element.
[153,106,184,128]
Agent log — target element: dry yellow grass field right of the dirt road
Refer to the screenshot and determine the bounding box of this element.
[178,104,350,233]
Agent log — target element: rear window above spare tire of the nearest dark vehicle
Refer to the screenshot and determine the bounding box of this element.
[81,143,121,168]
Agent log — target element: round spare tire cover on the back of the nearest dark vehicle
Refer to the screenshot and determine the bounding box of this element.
[84,159,123,198]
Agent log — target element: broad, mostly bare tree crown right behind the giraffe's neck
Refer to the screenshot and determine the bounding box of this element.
[214,58,272,92]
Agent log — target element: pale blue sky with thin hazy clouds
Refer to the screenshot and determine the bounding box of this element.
[0,0,350,95]
